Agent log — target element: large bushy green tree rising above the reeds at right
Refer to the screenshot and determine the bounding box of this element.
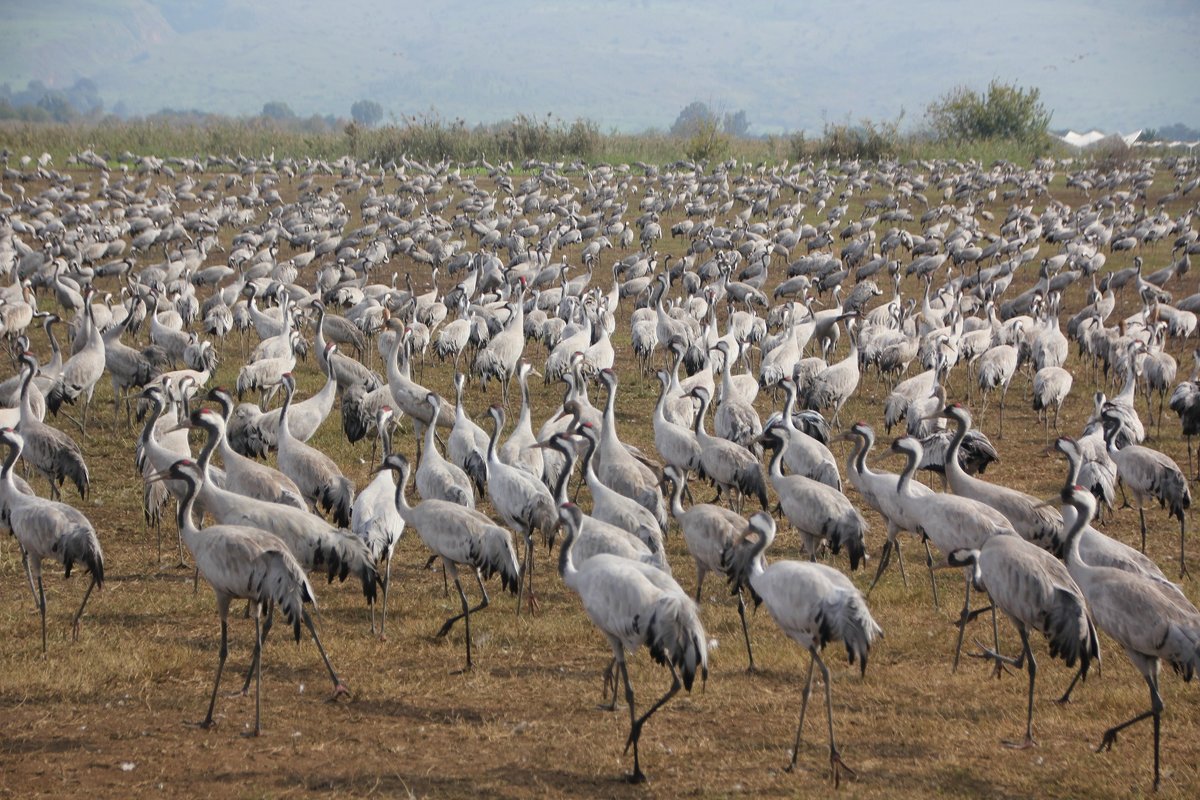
[926,80,1051,142]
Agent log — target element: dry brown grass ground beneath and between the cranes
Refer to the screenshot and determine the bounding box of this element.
[0,159,1200,798]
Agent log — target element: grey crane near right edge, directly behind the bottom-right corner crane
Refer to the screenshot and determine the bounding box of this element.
[1100,405,1192,578]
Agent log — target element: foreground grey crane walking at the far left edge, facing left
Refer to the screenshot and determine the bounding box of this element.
[0,428,104,652]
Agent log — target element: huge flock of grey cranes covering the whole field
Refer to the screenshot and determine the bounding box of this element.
[0,146,1200,788]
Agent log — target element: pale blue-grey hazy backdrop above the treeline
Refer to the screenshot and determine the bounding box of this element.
[0,0,1200,133]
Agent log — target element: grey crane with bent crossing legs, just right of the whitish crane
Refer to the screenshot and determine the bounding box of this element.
[379,453,521,669]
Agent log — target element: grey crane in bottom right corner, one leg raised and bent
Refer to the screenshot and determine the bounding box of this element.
[1062,486,1200,790]
